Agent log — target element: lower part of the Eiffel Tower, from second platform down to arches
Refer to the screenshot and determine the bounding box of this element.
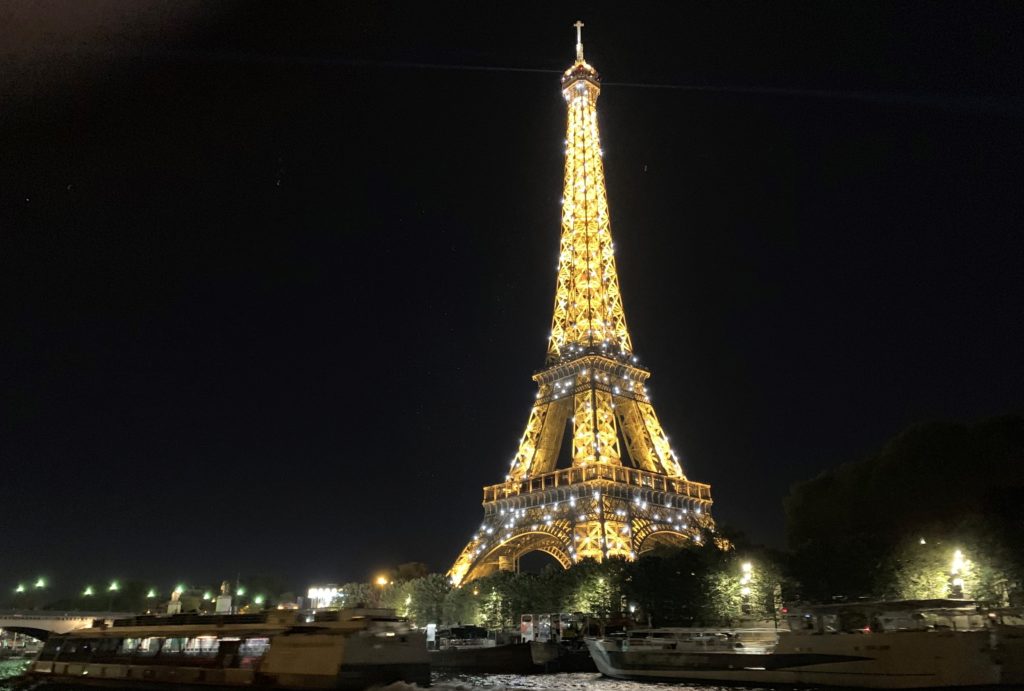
[450,352,714,584]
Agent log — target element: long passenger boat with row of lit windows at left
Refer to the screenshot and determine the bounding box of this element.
[19,608,430,690]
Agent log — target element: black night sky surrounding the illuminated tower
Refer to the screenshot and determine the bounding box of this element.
[0,0,1024,590]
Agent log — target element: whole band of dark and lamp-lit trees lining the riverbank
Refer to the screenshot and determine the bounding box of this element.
[2,416,1024,631]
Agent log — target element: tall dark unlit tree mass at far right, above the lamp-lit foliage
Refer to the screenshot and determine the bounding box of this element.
[784,416,1024,600]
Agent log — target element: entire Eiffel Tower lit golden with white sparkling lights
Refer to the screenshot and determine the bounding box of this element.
[449,21,714,586]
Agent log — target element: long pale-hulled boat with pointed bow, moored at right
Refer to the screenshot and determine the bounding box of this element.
[587,600,1024,689]
